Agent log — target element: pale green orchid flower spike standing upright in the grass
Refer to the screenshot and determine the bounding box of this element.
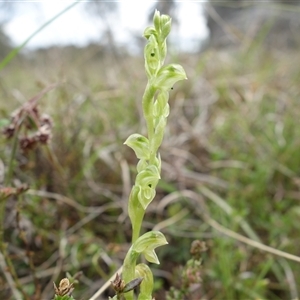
[122,11,187,300]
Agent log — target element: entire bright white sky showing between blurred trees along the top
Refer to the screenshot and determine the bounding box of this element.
[4,0,208,51]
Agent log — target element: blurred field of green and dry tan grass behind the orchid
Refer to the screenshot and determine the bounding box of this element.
[0,15,300,299]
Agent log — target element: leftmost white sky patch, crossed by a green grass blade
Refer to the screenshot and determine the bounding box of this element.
[5,1,102,48]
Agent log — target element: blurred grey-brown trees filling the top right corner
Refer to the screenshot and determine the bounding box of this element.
[205,0,300,48]
